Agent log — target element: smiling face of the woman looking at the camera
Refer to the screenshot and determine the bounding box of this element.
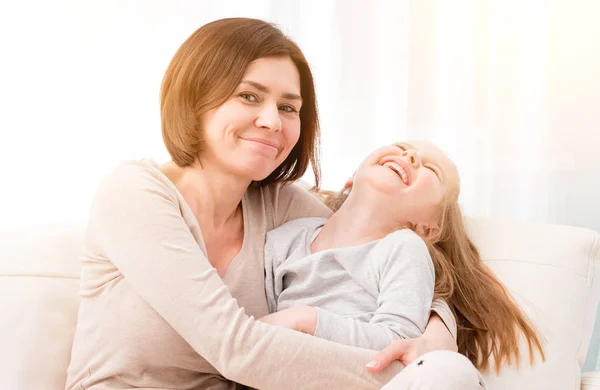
[199,57,302,181]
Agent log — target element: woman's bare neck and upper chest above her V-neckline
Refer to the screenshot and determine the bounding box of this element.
[163,162,250,230]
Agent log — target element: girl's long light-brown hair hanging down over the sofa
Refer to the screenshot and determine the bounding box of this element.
[317,187,546,372]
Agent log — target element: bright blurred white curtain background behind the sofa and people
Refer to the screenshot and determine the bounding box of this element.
[0,0,600,370]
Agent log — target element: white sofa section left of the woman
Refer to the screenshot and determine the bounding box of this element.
[0,224,83,389]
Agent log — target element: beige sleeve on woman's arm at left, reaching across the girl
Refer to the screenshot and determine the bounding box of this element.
[88,165,400,389]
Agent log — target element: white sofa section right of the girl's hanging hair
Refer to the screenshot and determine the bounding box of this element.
[467,218,600,390]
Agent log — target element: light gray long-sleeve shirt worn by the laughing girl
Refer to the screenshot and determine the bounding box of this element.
[265,218,435,349]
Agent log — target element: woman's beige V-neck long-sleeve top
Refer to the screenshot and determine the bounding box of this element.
[66,160,456,390]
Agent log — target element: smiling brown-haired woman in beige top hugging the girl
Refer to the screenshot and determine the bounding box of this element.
[67,19,470,389]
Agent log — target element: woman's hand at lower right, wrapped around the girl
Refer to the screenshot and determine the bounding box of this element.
[367,313,458,372]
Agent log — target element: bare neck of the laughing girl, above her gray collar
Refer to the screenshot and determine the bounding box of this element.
[311,193,401,253]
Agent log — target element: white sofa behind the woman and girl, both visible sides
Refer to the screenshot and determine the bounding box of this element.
[0,218,600,390]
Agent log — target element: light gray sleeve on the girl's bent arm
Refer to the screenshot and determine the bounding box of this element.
[315,230,435,349]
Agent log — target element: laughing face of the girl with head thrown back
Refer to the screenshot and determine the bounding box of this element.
[352,141,459,232]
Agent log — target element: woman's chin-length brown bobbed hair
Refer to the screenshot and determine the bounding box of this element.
[160,18,321,187]
